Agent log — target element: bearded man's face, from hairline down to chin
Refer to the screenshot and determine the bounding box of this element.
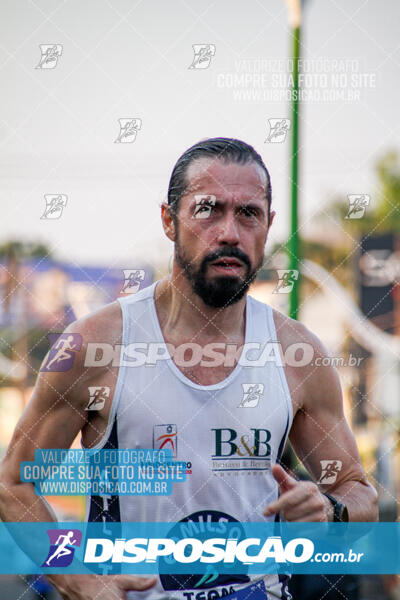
[175,159,268,308]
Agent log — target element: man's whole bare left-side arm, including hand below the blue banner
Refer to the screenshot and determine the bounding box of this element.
[0,309,155,600]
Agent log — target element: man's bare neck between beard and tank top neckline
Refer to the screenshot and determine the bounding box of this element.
[155,270,246,342]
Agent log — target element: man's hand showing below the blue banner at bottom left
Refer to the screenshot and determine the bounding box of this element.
[46,575,157,600]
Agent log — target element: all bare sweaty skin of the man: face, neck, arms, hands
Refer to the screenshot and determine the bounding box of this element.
[0,159,377,600]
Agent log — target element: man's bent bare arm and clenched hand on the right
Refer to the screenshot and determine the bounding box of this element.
[264,336,378,522]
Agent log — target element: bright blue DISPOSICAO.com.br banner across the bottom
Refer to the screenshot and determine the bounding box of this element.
[0,521,400,574]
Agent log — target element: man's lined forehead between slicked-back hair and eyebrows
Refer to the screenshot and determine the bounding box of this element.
[185,158,267,199]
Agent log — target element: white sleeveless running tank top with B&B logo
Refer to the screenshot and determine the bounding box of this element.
[86,282,293,600]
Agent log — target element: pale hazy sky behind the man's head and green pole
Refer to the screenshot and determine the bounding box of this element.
[0,0,400,267]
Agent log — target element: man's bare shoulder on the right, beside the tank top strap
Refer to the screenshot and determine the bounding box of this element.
[273,310,342,412]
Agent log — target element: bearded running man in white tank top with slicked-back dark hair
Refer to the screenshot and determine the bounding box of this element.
[0,138,377,600]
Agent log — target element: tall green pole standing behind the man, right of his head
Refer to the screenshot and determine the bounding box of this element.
[287,26,300,319]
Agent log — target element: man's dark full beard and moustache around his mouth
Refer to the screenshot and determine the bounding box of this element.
[175,241,263,308]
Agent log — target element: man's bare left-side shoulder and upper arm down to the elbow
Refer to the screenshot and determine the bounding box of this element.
[2,302,122,482]
